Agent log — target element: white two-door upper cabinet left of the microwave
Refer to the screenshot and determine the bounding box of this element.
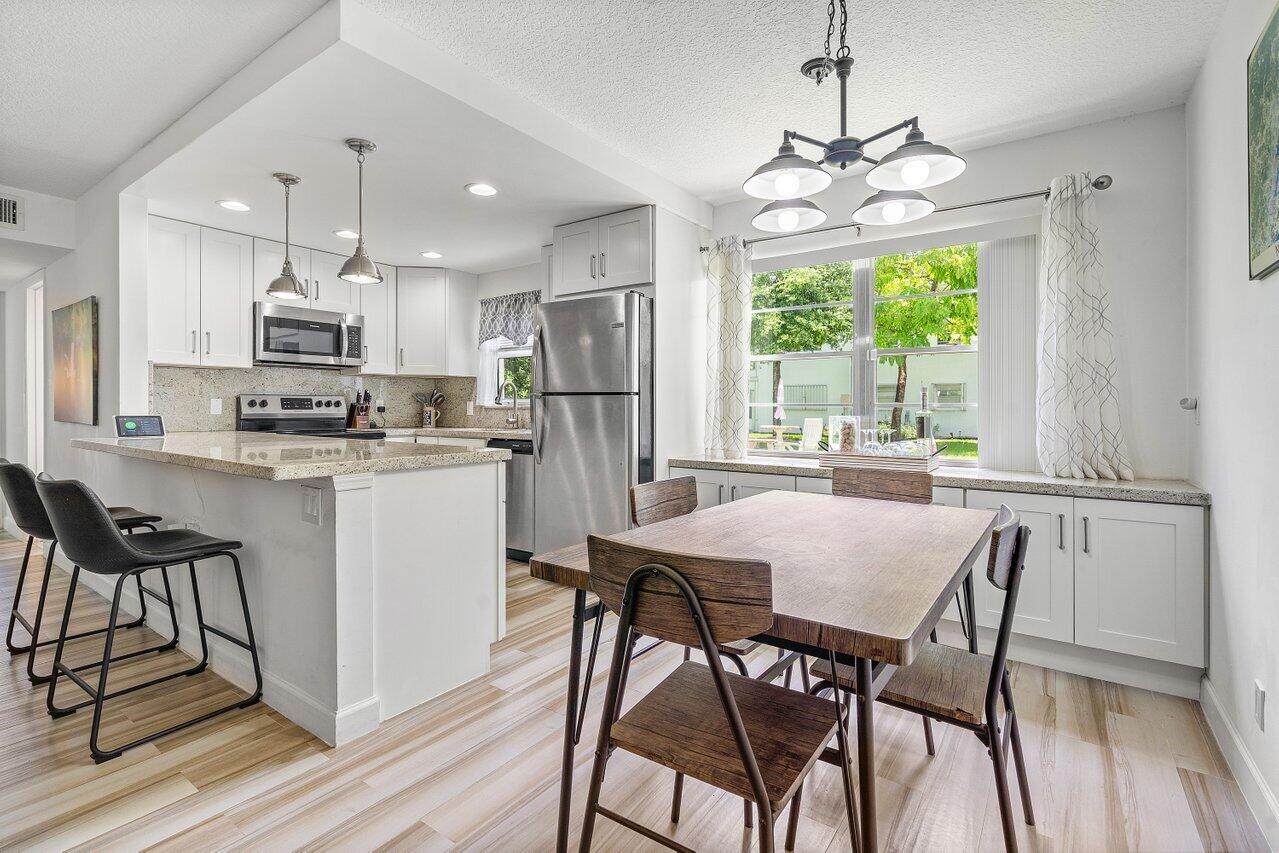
[147,216,253,367]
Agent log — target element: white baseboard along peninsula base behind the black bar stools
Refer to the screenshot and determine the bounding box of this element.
[54,551,368,747]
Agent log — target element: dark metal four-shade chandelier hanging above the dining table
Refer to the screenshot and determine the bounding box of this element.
[742,0,966,233]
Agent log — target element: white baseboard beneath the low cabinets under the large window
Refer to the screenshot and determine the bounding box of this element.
[938,619,1204,700]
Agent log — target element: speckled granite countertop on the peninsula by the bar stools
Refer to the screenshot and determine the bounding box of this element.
[70,432,510,480]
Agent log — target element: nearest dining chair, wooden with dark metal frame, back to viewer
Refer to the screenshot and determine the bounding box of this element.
[579,536,857,853]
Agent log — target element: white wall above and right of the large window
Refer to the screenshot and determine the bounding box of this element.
[714,106,1186,477]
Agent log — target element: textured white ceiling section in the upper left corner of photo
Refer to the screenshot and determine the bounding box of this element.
[0,0,324,198]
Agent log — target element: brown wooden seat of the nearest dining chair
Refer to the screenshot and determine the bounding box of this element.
[613,662,835,812]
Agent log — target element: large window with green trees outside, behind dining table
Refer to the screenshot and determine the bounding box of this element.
[749,243,977,463]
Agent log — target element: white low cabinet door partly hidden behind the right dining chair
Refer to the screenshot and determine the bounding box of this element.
[966,489,1074,642]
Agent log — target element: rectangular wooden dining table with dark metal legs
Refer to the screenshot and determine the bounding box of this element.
[530,491,996,852]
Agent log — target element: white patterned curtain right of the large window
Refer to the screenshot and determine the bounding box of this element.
[1035,174,1133,480]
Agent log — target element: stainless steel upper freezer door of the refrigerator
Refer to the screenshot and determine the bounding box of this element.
[533,293,642,394]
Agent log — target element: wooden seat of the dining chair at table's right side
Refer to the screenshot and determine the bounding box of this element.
[810,643,994,728]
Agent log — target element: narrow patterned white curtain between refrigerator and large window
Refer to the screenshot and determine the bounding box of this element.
[705,237,751,459]
